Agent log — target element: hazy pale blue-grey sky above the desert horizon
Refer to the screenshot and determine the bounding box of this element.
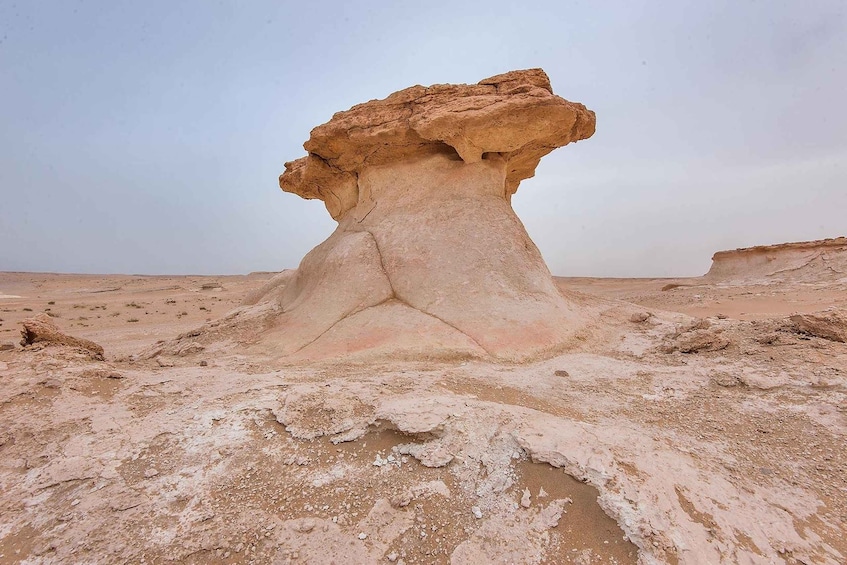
[0,0,847,276]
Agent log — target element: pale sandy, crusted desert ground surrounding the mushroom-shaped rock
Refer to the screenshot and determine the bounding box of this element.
[0,273,847,564]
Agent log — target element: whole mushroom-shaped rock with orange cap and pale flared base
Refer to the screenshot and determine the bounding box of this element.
[249,69,595,361]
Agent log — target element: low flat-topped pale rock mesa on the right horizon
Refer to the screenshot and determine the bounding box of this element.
[706,237,847,282]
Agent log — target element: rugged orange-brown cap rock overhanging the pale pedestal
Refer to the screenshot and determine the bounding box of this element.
[279,69,596,220]
